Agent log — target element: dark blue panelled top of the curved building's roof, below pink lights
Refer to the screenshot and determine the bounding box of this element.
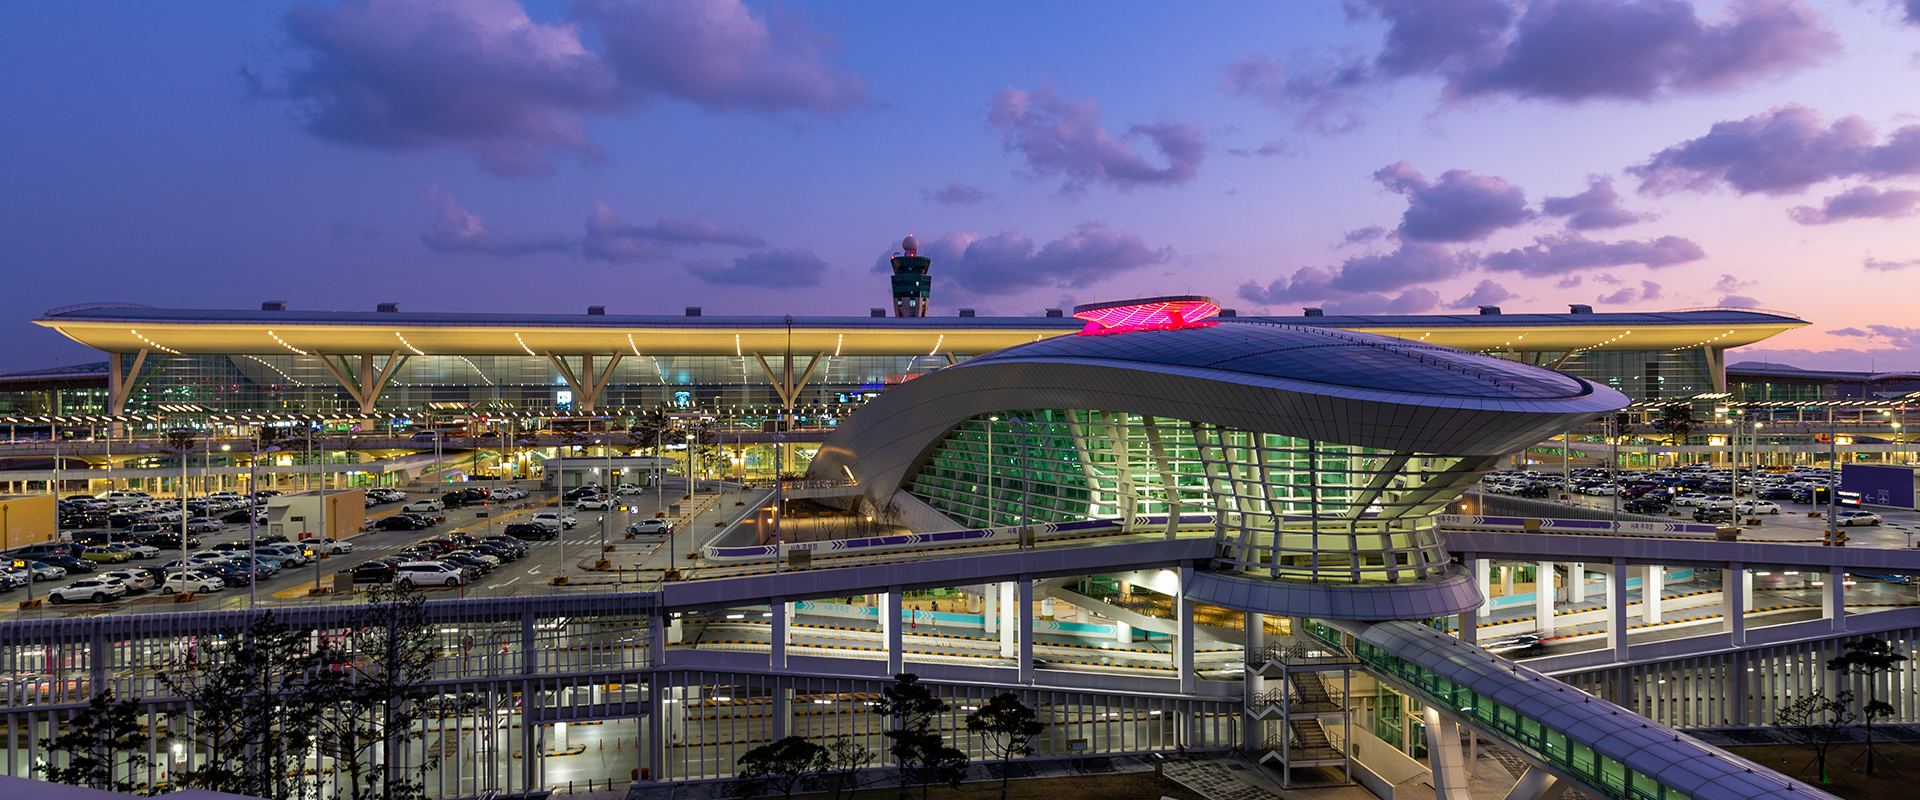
[972,320,1594,399]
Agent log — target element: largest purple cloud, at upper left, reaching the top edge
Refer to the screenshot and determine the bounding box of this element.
[255,0,866,175]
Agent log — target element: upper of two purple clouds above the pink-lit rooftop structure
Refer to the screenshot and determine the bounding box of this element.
[987,86,1206,194]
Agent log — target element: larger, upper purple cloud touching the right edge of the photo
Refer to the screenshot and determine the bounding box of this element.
[1628,106,1920,196]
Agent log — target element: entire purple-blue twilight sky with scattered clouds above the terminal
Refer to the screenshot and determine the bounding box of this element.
[0,0,1920,370]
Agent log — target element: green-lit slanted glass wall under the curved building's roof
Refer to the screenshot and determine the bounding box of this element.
[904,409,1492,583]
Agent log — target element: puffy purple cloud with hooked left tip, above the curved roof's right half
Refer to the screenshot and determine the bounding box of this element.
[1373,161,1534,242]
